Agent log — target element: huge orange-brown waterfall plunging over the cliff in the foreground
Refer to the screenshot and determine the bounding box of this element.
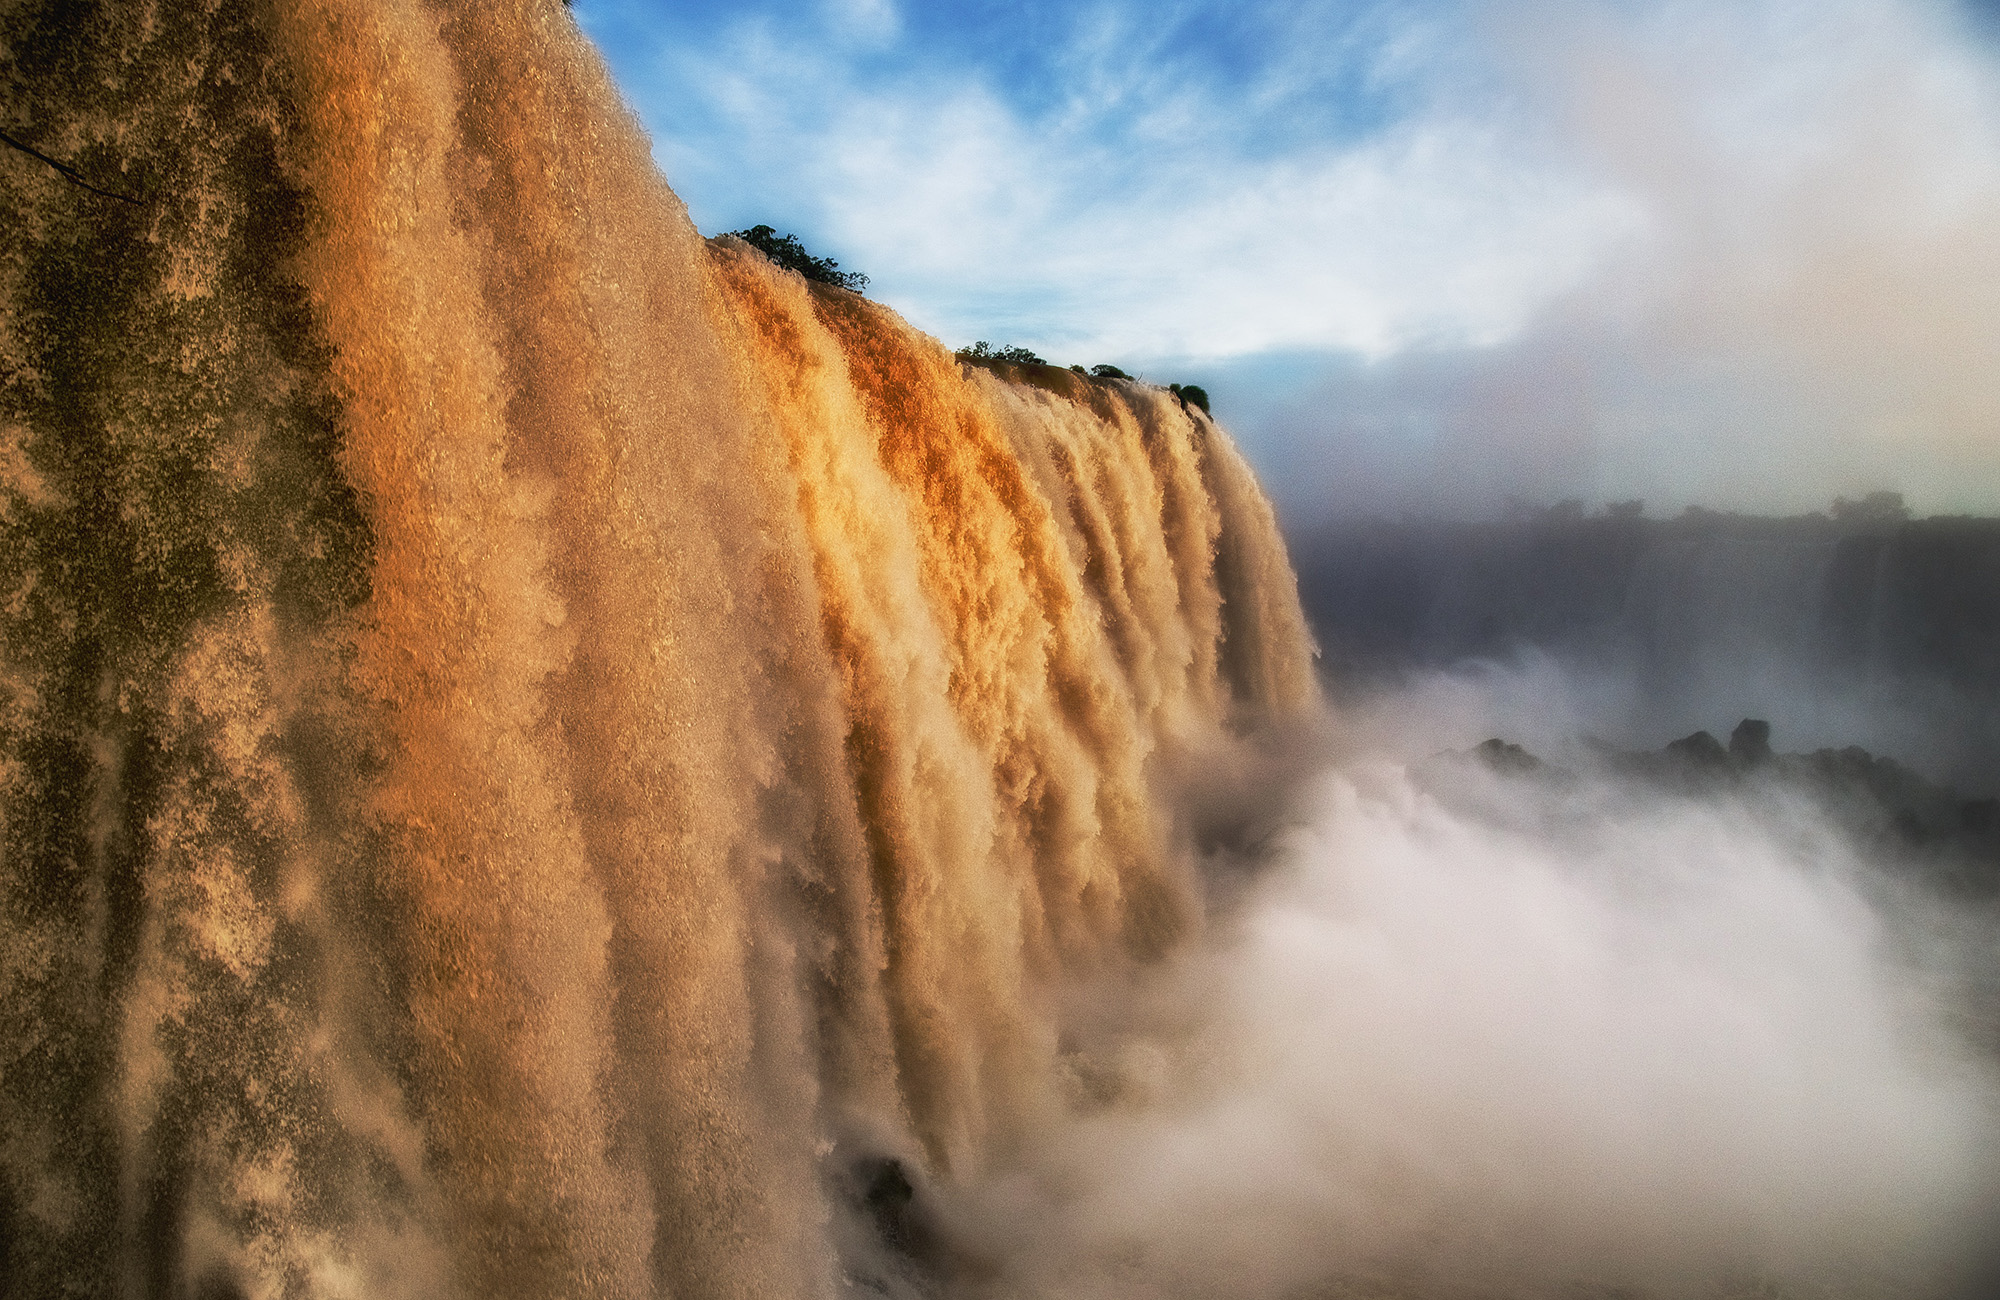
[0,0,1314,1296]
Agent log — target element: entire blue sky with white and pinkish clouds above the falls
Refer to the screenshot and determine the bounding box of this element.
[574,0,2000,518]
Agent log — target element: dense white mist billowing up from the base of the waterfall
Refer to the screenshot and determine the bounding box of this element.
[900,704,2000,1300]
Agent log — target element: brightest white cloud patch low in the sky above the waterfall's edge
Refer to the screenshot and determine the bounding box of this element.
[828,74,1638,356]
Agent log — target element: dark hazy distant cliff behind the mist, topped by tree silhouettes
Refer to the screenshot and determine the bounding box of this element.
[1292,512,2000,794]
